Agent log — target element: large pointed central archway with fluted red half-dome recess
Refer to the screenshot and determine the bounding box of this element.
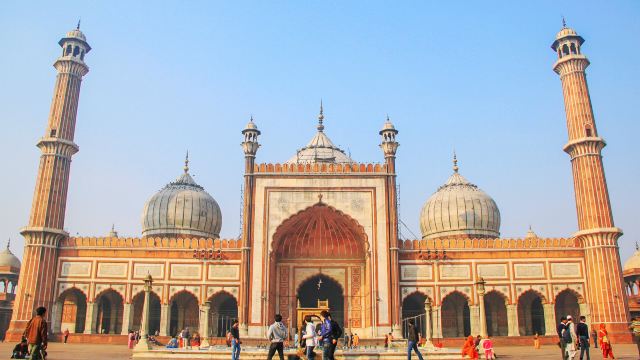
[265,201,371,332]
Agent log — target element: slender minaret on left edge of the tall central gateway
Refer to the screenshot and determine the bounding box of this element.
[238,116,260,337]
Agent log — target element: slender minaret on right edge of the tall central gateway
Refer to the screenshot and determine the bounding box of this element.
[379,115,402,339]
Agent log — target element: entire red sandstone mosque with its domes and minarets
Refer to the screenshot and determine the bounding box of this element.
[5,23,640,341]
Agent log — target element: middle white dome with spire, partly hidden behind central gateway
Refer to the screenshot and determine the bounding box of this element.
[287,102,354,164]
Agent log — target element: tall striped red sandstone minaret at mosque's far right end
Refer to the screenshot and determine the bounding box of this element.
[551,20,629,335]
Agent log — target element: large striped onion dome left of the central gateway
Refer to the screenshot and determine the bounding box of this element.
[142,153,222,238]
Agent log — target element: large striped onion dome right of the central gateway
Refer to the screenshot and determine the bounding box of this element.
[420,154,500,239]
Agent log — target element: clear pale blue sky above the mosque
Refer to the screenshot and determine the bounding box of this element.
[0,1,640,261]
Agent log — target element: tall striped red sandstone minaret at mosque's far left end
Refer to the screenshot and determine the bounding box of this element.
[7,23,91,340]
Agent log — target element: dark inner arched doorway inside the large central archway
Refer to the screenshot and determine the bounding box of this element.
[296,274,345,328]
